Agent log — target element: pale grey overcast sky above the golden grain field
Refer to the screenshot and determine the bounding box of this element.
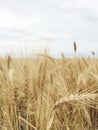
[0,0,98,56]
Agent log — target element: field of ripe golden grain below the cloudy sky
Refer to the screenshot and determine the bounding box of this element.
[0,54,98,130]
